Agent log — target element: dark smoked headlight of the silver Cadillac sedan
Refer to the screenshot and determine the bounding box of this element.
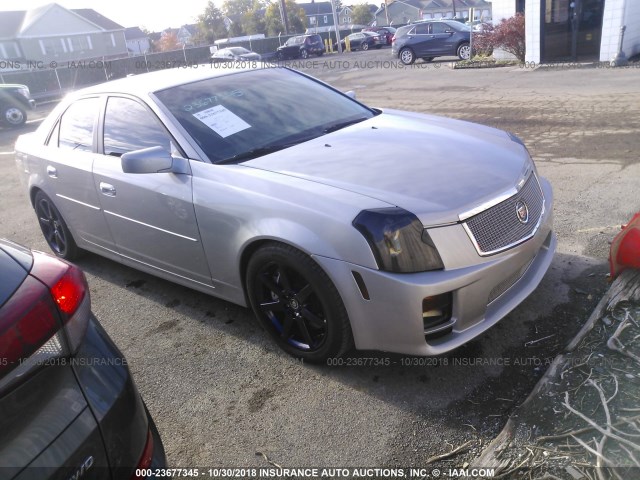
[353,207,444,273]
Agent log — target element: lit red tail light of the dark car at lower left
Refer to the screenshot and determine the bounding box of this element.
[0,252,90,388]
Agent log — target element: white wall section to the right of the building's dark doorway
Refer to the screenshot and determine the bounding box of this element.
[600,0,640,62]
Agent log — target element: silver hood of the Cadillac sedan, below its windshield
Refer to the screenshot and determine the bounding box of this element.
[242,110,529,226]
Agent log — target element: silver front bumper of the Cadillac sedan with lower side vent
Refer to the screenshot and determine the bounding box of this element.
[315,177,557,355]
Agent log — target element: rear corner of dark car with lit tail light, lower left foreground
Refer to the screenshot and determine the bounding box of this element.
[0,240,166,480]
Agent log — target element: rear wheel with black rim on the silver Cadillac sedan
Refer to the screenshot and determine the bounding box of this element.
[34,191,81,260]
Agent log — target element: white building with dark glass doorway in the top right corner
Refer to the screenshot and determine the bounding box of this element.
[492,0,640,63]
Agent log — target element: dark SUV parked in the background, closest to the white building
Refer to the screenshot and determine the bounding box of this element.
[391,20,471,65]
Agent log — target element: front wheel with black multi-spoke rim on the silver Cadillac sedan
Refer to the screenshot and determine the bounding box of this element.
[247,242,353,363]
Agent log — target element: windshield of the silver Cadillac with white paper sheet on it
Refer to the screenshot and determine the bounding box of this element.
[156,68,375,163]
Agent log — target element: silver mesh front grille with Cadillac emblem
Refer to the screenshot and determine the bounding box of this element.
[463,173,544,256]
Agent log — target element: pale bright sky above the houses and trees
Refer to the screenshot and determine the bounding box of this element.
[0,0,370,31]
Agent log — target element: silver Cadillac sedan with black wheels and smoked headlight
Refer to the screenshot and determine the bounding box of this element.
[16,66,556,362]
